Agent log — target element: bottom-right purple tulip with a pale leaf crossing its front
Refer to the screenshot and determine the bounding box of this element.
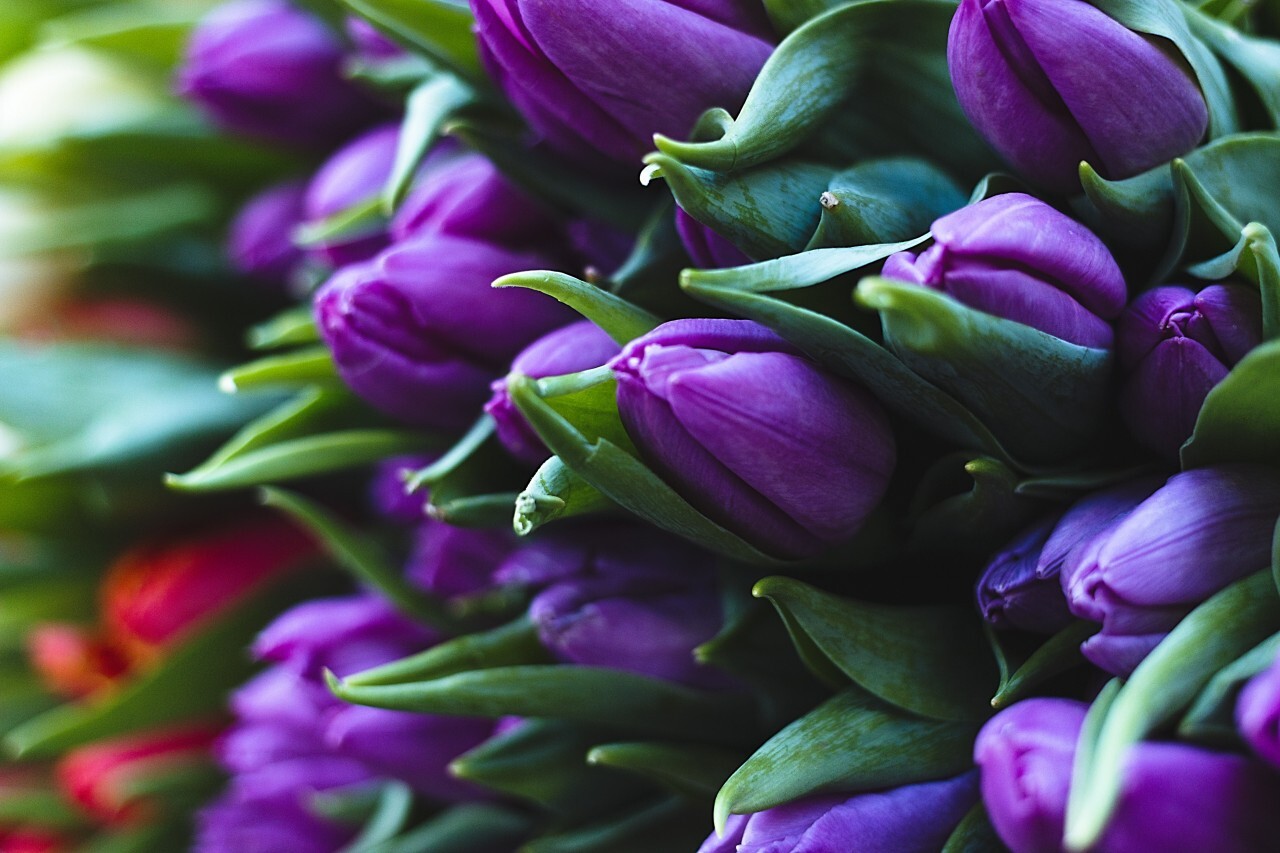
[974,699,1280,853]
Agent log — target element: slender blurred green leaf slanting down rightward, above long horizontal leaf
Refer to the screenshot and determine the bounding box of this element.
[262,488,457,633]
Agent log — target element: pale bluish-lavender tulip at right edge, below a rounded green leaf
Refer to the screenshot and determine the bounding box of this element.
[1061,465,1280,675]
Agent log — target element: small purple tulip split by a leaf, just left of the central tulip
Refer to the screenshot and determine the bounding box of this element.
[484,320,618,465]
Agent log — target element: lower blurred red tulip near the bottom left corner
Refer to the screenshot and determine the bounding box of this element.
[58,724,219,824]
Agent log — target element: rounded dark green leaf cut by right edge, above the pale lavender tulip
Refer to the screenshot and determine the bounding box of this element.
[1183,341,1280,467]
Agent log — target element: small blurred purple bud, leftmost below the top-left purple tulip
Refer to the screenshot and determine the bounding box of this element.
[227,181,306,284]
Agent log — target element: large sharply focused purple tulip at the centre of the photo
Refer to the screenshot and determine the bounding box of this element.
[611,320,895,558]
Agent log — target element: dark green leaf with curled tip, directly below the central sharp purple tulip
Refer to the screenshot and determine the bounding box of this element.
[753,576,996,721]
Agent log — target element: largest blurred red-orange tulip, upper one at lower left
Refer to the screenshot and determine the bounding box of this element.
[102,516,316,661]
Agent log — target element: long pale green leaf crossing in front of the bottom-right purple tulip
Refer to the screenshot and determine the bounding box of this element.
[1065,569,1280,850]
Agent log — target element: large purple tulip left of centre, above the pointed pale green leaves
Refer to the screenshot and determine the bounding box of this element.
[315,233,572,430]
